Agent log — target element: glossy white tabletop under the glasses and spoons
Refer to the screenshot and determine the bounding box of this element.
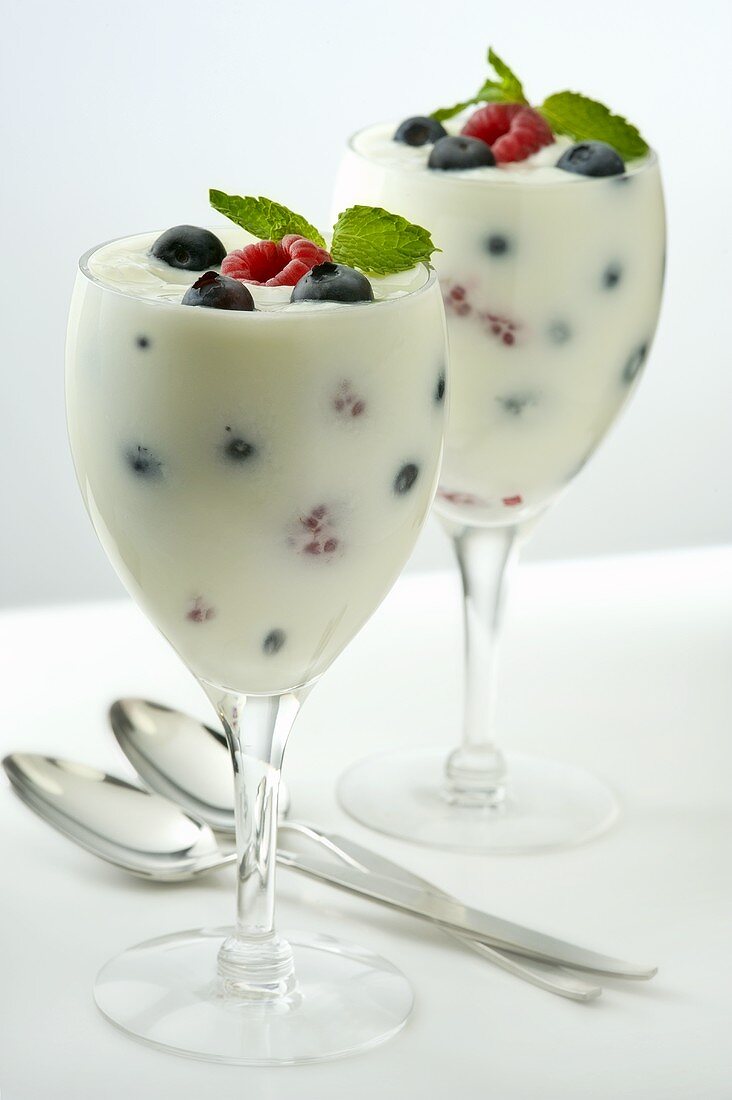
[0,549,732,1100]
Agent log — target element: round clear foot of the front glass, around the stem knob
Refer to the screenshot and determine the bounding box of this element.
[95,928,413,1066]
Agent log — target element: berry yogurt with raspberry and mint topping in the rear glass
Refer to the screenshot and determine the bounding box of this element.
[336,54,665,525]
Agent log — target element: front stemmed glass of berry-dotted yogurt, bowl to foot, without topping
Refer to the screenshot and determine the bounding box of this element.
[67,239,446,1065]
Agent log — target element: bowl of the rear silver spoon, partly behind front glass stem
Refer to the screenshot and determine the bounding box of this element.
[109,699,289,836]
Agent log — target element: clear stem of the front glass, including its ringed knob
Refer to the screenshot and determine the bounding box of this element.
[204,684,308,1003]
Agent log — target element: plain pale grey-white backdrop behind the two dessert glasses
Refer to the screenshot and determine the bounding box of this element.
[0,0,732,604]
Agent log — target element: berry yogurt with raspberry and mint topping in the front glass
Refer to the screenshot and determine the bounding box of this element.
[67,193,446,693]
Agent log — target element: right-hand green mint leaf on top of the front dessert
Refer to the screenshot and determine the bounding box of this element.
[330,206,440,275]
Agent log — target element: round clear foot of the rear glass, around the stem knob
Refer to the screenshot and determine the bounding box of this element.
[338,748,619,855]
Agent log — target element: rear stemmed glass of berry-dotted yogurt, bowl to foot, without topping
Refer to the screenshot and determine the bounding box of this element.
[336,137,665,853]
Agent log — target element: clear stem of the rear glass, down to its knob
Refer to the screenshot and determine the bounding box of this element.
[444,525,523,807]
